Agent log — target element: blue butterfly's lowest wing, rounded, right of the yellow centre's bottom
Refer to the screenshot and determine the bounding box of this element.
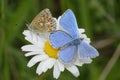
[58,46,77,63]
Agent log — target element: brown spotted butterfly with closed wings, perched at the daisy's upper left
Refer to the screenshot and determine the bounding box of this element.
[28,8,57,33]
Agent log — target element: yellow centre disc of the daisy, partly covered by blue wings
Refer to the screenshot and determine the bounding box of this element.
[44,41,58,59]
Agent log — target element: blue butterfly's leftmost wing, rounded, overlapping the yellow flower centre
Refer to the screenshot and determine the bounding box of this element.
[49,30,72,48]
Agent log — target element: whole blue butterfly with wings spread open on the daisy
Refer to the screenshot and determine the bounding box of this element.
[49,9,99,63]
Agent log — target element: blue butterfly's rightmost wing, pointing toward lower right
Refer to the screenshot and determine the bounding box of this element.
[78,41,99,58]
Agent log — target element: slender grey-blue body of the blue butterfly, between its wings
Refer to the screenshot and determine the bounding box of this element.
[60,38,82,50]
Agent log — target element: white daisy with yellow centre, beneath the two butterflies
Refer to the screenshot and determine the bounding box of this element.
[22,29,92,79]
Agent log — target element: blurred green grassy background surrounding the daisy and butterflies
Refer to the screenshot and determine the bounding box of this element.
[0,0,120,80]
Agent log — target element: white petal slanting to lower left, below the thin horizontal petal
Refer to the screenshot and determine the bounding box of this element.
[27,55,48,67]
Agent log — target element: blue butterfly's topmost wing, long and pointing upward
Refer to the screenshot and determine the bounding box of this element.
[59,9,79,38]
